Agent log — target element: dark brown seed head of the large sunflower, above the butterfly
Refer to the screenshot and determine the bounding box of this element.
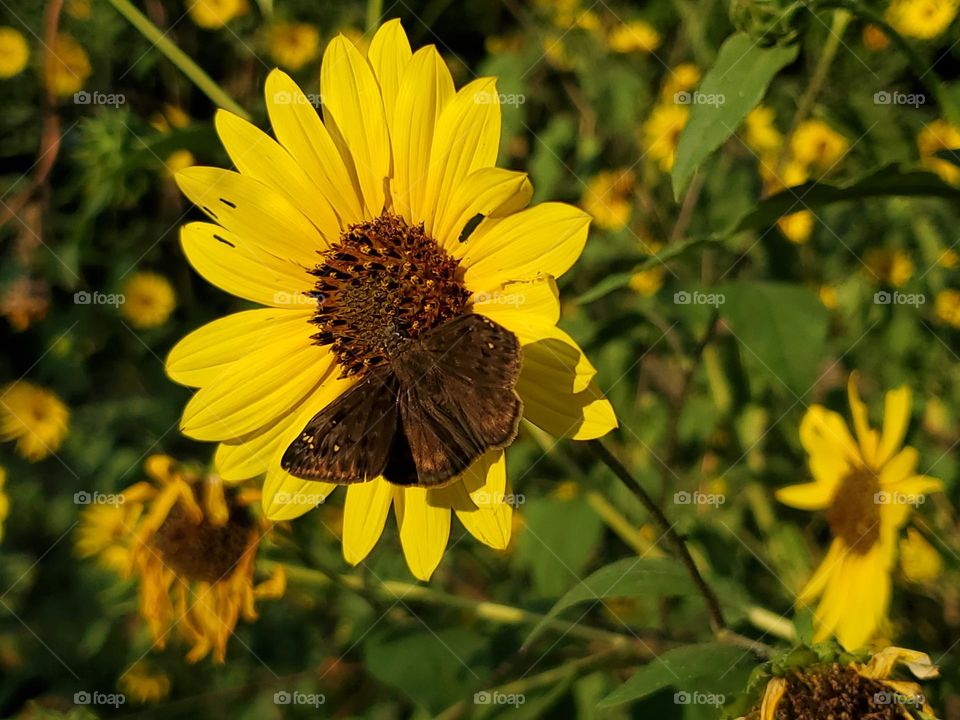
[307,213,470,377]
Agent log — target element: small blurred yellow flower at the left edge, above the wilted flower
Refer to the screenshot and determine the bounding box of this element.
[0,380,70,462]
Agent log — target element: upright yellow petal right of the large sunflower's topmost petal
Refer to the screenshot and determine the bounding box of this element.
[390,45,454,225]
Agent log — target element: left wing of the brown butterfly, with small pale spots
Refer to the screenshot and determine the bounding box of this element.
[280,366,397,485]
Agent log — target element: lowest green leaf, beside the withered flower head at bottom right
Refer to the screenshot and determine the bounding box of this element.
[597,643,753,708]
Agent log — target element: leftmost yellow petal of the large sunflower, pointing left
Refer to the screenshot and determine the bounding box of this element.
[166,308,312,387]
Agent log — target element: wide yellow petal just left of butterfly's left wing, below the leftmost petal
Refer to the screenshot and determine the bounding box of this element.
[180,324,336,440]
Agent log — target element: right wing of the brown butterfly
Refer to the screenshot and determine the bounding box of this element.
[388,315,523,487]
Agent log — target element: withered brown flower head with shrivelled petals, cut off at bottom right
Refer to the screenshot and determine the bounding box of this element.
[740,647,939,720]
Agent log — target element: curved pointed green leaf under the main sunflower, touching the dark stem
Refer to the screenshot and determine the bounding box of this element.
[524,558,696,645]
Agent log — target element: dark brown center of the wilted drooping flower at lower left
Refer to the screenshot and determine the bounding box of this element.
[152,494,253,583]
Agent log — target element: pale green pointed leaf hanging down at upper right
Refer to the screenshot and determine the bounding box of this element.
[673,33,797,200]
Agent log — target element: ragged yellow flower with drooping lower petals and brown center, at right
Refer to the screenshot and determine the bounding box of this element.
[776,373,943,650]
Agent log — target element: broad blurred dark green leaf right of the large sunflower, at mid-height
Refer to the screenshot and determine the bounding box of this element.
[716,281,829,396]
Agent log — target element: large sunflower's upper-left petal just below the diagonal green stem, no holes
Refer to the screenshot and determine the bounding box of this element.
[214,110,341,239]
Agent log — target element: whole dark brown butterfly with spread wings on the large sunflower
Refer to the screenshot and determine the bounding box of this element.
[280,314,523,487]
